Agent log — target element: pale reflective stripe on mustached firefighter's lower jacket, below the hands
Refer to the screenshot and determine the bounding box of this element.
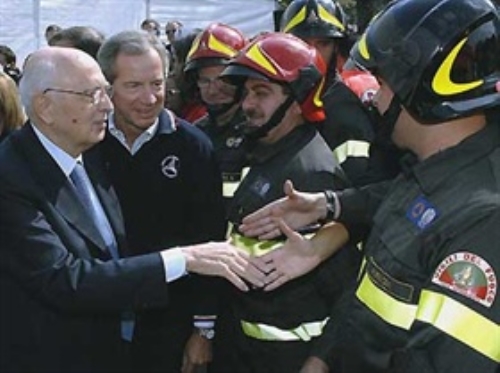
[241,317,329,341]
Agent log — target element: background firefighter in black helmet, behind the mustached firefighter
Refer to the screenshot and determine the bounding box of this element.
[280,0,393,186]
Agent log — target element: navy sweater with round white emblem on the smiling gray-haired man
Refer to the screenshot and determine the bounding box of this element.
[98,110,226,373]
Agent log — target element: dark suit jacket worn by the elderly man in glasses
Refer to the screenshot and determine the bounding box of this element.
[0,125,167,373]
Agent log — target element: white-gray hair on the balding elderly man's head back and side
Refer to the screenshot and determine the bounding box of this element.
[19,56,58,117]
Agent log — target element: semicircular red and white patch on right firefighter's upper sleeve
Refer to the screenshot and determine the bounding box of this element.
[432,252,497,307]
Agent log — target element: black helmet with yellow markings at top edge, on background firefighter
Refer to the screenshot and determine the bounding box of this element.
[280,0,347,39]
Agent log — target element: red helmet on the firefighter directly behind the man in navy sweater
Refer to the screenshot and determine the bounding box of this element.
[184,23,247,72]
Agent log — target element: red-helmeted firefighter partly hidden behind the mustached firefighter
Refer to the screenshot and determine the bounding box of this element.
[184,23,247,214]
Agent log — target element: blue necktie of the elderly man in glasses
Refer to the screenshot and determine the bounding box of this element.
[69,162,134,341]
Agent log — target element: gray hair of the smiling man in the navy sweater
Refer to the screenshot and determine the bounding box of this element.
[97,31,169,83]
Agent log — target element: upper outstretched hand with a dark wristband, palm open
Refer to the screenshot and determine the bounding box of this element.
[238,180,326,240]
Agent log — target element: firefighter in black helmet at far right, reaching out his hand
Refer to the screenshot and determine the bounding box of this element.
[240,0,500,373]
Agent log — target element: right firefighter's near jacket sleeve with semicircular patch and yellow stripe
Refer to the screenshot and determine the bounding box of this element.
[397,207,500,373]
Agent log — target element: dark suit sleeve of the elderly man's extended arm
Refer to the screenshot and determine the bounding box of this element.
[0,170,168,313]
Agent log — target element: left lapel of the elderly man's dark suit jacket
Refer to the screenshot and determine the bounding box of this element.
[17,125,108,253]
